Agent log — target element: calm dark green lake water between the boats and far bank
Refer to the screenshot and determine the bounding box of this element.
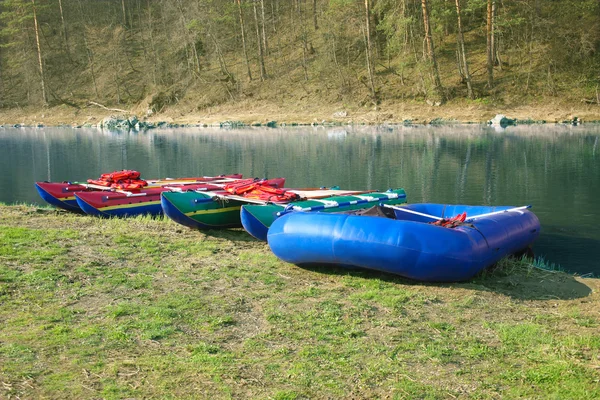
[0,125,600,276]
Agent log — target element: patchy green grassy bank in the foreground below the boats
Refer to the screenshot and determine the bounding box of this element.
[0,205,600,399]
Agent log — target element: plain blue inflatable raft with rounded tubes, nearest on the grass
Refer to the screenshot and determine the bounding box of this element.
[268,204,540,282]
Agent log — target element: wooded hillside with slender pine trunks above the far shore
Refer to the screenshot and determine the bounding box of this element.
[0,0,600,112]
